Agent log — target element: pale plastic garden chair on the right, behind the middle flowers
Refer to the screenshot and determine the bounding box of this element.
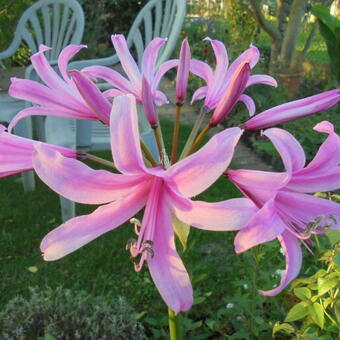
[56,0,186,155]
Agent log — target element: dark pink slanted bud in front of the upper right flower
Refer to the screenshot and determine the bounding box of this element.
[210,62,250,126]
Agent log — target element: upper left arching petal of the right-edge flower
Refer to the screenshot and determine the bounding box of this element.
[263,128,306,172]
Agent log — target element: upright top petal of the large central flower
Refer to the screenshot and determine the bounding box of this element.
[110,94,146,174]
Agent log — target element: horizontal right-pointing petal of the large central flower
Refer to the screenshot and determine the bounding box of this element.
[168,193,258,231]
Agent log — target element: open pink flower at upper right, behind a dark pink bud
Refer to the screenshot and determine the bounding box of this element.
[190,38,277,116]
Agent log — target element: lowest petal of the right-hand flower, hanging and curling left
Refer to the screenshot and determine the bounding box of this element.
[260,231,302,296]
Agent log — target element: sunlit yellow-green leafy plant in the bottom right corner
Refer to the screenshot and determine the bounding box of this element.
[273,243,340,340]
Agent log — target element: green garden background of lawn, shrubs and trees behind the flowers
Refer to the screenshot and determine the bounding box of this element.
[0,0,340,340]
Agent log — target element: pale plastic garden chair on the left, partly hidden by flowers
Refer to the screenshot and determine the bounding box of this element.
[0,0,84,220]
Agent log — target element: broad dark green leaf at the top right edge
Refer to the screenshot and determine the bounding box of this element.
[312,5,340,84]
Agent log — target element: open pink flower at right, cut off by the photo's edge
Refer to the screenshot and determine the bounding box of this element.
[228,121,340,295]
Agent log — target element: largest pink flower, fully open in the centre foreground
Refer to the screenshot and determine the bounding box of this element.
[34,95,257,313]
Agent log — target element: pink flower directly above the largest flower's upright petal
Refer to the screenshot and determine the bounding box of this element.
[82,34,178,105]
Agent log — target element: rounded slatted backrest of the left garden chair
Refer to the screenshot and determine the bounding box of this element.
[0,0,84,60]
